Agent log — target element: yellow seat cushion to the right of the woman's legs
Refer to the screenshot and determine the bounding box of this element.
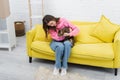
[71,43,114,60]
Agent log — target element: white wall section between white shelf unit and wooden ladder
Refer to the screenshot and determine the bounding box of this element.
[9,0,30,31]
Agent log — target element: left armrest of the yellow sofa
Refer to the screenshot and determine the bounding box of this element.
[26,28,36,56]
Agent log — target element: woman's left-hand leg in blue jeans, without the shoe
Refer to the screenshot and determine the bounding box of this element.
[50,41,64,69]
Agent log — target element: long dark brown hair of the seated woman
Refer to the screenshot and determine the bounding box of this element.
[42,15,59,38]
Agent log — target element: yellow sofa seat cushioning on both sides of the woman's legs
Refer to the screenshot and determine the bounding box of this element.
[31,41,114,60]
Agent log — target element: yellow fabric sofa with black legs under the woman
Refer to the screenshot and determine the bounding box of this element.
[26,15,120,75]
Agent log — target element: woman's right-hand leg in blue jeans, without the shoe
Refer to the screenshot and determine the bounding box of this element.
[62,40,72,69]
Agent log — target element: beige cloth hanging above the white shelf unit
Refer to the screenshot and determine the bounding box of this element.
[0,0,10,19]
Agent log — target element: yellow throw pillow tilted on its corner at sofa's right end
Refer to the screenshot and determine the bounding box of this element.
[92,16,119,42]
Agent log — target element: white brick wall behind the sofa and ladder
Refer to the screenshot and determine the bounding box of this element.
[10,0,120,30]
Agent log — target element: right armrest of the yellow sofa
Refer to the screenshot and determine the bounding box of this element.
[113,30,120,68]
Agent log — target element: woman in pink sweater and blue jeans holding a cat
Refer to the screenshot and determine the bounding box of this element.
[43,15,79,75]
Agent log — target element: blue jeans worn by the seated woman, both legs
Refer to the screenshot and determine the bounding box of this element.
[50,40,72,69]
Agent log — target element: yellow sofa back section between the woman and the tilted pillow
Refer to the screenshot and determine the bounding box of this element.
[72,21,103,44]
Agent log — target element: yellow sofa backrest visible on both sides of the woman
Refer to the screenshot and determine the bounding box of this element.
[34,21,102,44]
